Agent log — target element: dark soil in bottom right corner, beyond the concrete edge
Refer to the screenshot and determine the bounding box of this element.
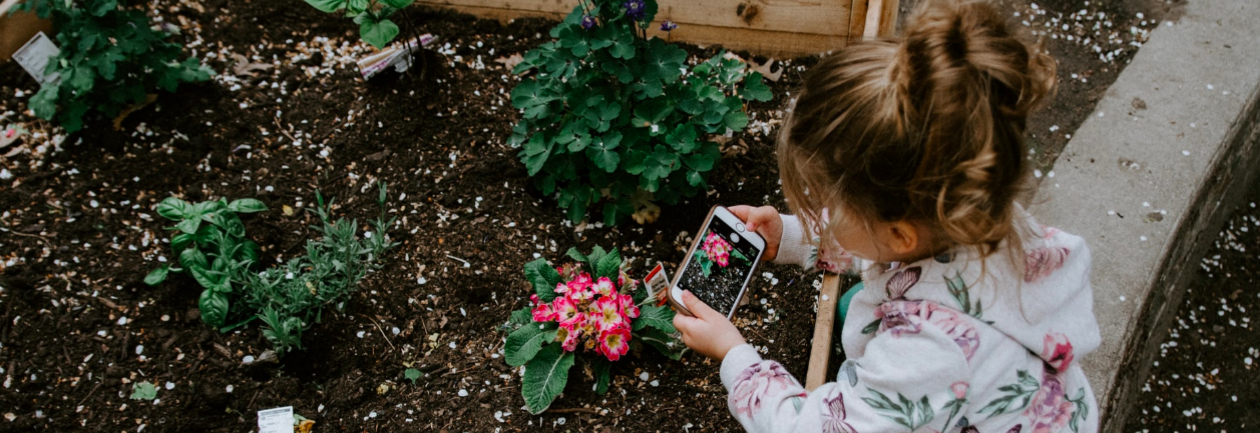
[1124,190,1260,433]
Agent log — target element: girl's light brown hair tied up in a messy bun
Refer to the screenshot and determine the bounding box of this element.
[779,0,1056,257]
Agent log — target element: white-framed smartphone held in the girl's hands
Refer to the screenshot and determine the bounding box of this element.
[668,206,766,318]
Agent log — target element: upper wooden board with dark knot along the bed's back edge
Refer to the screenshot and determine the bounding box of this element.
[416,0,852,35]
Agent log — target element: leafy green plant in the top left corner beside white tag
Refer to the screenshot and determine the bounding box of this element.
[16,0,214,132]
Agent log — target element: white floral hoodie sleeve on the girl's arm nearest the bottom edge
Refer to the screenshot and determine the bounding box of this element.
[721,315,970,433]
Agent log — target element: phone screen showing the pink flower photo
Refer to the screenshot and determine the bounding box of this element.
[675,215,760,317]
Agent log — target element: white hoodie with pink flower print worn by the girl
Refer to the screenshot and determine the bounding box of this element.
[722,215,1100,433]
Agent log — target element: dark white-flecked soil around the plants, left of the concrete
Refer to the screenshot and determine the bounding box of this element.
[0,0,1174,432]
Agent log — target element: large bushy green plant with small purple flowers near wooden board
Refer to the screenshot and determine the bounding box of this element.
[510,0,771,225]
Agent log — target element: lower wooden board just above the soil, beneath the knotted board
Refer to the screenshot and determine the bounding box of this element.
[418,0,848,58]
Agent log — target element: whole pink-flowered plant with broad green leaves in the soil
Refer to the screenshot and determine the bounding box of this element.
[504,247,683,414]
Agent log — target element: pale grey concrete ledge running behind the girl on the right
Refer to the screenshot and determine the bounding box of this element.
[1032,0,1260,432]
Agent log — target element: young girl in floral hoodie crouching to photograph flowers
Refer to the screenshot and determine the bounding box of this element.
[674,0,1100,433]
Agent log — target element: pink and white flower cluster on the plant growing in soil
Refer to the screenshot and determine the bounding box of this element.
[529,266,639,361]
